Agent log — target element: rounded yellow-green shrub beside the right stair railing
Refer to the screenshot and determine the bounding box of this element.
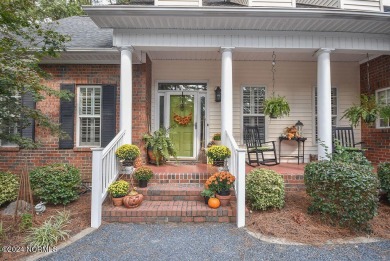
[246,169,284,210]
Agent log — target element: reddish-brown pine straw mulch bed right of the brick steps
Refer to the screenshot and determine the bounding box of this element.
[247,192,390,245]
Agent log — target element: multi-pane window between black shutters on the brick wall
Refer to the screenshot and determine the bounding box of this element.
[78,86,102,146]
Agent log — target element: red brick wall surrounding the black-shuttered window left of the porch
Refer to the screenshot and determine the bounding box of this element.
[0,58,152,180]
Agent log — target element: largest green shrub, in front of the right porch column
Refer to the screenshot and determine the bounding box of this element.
[304,160,378,230]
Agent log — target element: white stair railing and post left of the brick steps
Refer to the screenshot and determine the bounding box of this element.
[91,130,125,228]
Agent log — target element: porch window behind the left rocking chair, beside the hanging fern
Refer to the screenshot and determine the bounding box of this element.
[242,87,265,141]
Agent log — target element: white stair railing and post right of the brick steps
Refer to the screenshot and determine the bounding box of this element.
[226,131,245,227]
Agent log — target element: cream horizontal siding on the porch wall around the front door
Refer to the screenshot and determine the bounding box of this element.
[152,58,360,162]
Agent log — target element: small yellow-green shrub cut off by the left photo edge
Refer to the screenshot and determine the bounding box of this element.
[0,172,19,206]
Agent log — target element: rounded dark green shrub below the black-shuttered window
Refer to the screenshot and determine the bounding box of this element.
[30,164,81,205]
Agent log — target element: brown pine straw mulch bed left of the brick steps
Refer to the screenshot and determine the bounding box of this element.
[0,192,91,260]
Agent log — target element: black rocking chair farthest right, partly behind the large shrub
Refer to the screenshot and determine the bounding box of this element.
[332,126,364,153]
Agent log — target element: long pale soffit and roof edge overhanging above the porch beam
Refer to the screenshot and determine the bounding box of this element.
[84,6,390,35]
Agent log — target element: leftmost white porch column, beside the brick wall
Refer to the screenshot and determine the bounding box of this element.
[119,46,134,144]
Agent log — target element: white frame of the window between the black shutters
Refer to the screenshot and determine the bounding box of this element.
[76,85,103,148]
